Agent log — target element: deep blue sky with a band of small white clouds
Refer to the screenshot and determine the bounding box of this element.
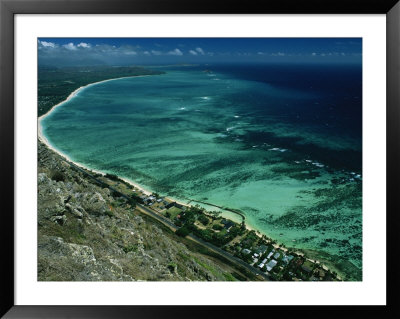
[38,38,362,66]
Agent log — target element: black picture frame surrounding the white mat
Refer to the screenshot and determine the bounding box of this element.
[0,0,400,318]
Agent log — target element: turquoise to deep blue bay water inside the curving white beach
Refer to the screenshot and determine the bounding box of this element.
[42,67,362,276]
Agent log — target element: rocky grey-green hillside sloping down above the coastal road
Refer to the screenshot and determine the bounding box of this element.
[38,142,233,281]
